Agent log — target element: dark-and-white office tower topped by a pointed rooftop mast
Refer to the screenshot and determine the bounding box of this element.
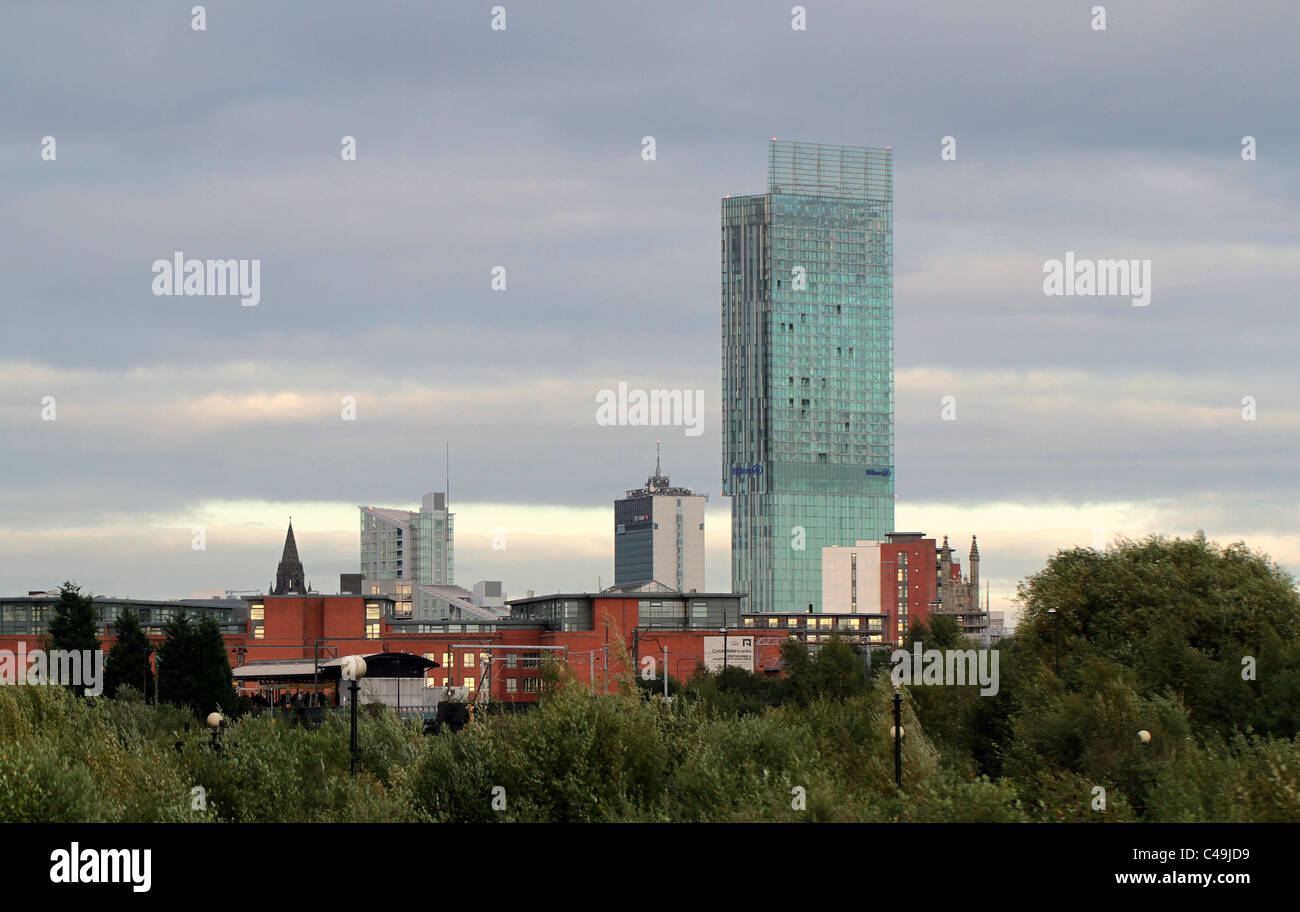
[614,452,709,592]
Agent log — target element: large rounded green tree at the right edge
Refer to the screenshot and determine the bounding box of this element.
[1017,533,1300,738]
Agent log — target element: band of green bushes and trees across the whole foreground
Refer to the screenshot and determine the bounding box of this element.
[0,537,1300,822]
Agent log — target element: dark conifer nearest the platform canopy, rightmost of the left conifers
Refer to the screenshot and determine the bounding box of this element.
[157,614,235,717]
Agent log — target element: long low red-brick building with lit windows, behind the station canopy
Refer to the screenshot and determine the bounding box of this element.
[241,592,754,711]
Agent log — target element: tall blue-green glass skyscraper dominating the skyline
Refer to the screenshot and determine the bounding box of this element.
[722,139,894,612]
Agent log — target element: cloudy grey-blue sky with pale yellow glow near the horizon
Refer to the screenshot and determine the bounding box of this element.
[0,0,1300,620]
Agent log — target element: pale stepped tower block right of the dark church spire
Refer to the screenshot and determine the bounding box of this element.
[360,492,455,589]
